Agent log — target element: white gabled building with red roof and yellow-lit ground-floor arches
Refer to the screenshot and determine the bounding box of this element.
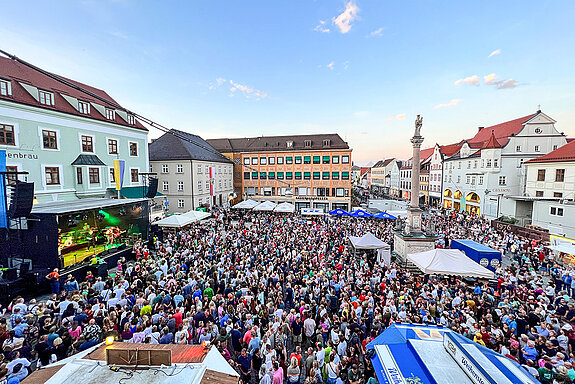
[442,111,567,218]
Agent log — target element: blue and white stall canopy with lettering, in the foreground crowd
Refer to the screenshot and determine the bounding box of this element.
[367,324,538,384]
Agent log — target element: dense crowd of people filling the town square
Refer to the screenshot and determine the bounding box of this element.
[0,210,575,384]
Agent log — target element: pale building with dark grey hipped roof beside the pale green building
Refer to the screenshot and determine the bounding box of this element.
[149,129,234,212]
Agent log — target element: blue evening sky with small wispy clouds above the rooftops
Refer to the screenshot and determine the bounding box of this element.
[0,0,575,164]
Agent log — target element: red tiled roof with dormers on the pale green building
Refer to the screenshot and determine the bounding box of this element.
[0,57,147,131]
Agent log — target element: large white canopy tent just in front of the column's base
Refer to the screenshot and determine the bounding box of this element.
[407,248,493,279]
